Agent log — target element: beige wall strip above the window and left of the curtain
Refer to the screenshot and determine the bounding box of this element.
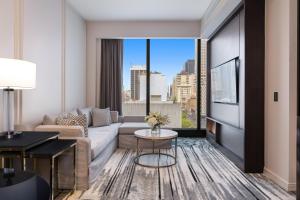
[87,21,200,106]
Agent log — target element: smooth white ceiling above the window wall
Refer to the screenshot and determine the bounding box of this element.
[68,0,214,21]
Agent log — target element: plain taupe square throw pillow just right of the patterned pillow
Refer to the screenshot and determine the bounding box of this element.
[92,108,111,127]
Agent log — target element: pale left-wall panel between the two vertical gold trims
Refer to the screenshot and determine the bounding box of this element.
[22,0,63,124]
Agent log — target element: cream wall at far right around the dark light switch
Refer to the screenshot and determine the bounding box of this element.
[265,0,297,190]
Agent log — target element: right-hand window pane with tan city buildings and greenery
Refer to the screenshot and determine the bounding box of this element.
[150,39,197,128]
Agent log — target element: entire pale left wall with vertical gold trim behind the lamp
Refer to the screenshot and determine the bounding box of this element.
[0,0,86,127]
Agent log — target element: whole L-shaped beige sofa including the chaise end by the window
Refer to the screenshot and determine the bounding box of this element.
[35,108,171,190]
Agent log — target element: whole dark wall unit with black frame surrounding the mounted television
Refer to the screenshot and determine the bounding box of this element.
[208,0,265,173]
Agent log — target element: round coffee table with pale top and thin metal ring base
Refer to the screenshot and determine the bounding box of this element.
[134,129,178,168]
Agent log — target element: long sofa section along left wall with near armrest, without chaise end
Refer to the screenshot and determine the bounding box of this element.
[35,123,121,189]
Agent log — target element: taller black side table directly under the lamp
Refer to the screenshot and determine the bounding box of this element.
[0,131,59,171]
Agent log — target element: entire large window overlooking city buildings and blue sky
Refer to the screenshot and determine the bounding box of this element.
[123,39,206,129]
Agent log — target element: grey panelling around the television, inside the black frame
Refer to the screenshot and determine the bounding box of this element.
[209,10,245,166]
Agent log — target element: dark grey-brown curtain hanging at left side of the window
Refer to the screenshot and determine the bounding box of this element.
[96,39,123,114]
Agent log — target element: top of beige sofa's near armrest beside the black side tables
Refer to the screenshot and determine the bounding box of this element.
[35,125,84,138]
